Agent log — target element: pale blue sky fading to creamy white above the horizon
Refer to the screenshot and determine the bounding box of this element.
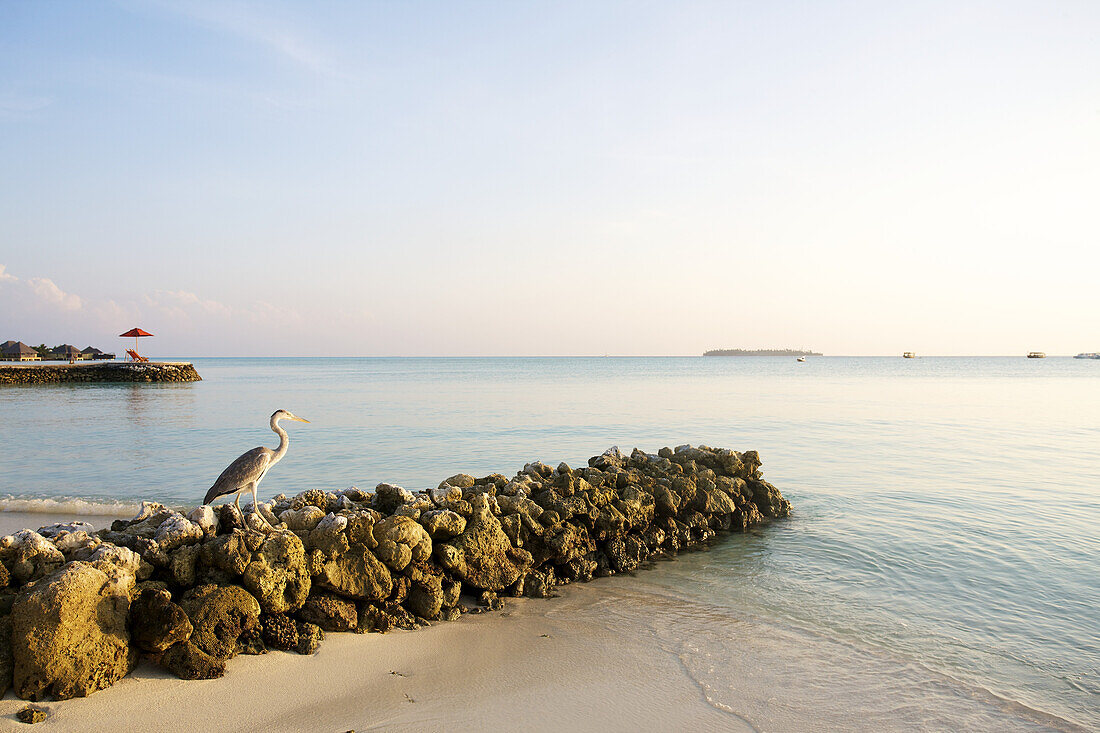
[0,0,1100,357]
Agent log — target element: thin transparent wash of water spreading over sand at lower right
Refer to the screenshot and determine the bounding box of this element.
[568,566,1091,733]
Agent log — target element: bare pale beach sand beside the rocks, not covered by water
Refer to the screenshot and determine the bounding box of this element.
[0,513,751,733]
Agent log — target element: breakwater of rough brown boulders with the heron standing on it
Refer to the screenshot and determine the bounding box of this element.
[0,446,790,700]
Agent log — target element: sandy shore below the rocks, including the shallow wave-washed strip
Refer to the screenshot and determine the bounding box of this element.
[0,513,1087,733]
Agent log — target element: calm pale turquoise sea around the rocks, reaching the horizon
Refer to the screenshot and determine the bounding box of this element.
[0,358,1100,730]
